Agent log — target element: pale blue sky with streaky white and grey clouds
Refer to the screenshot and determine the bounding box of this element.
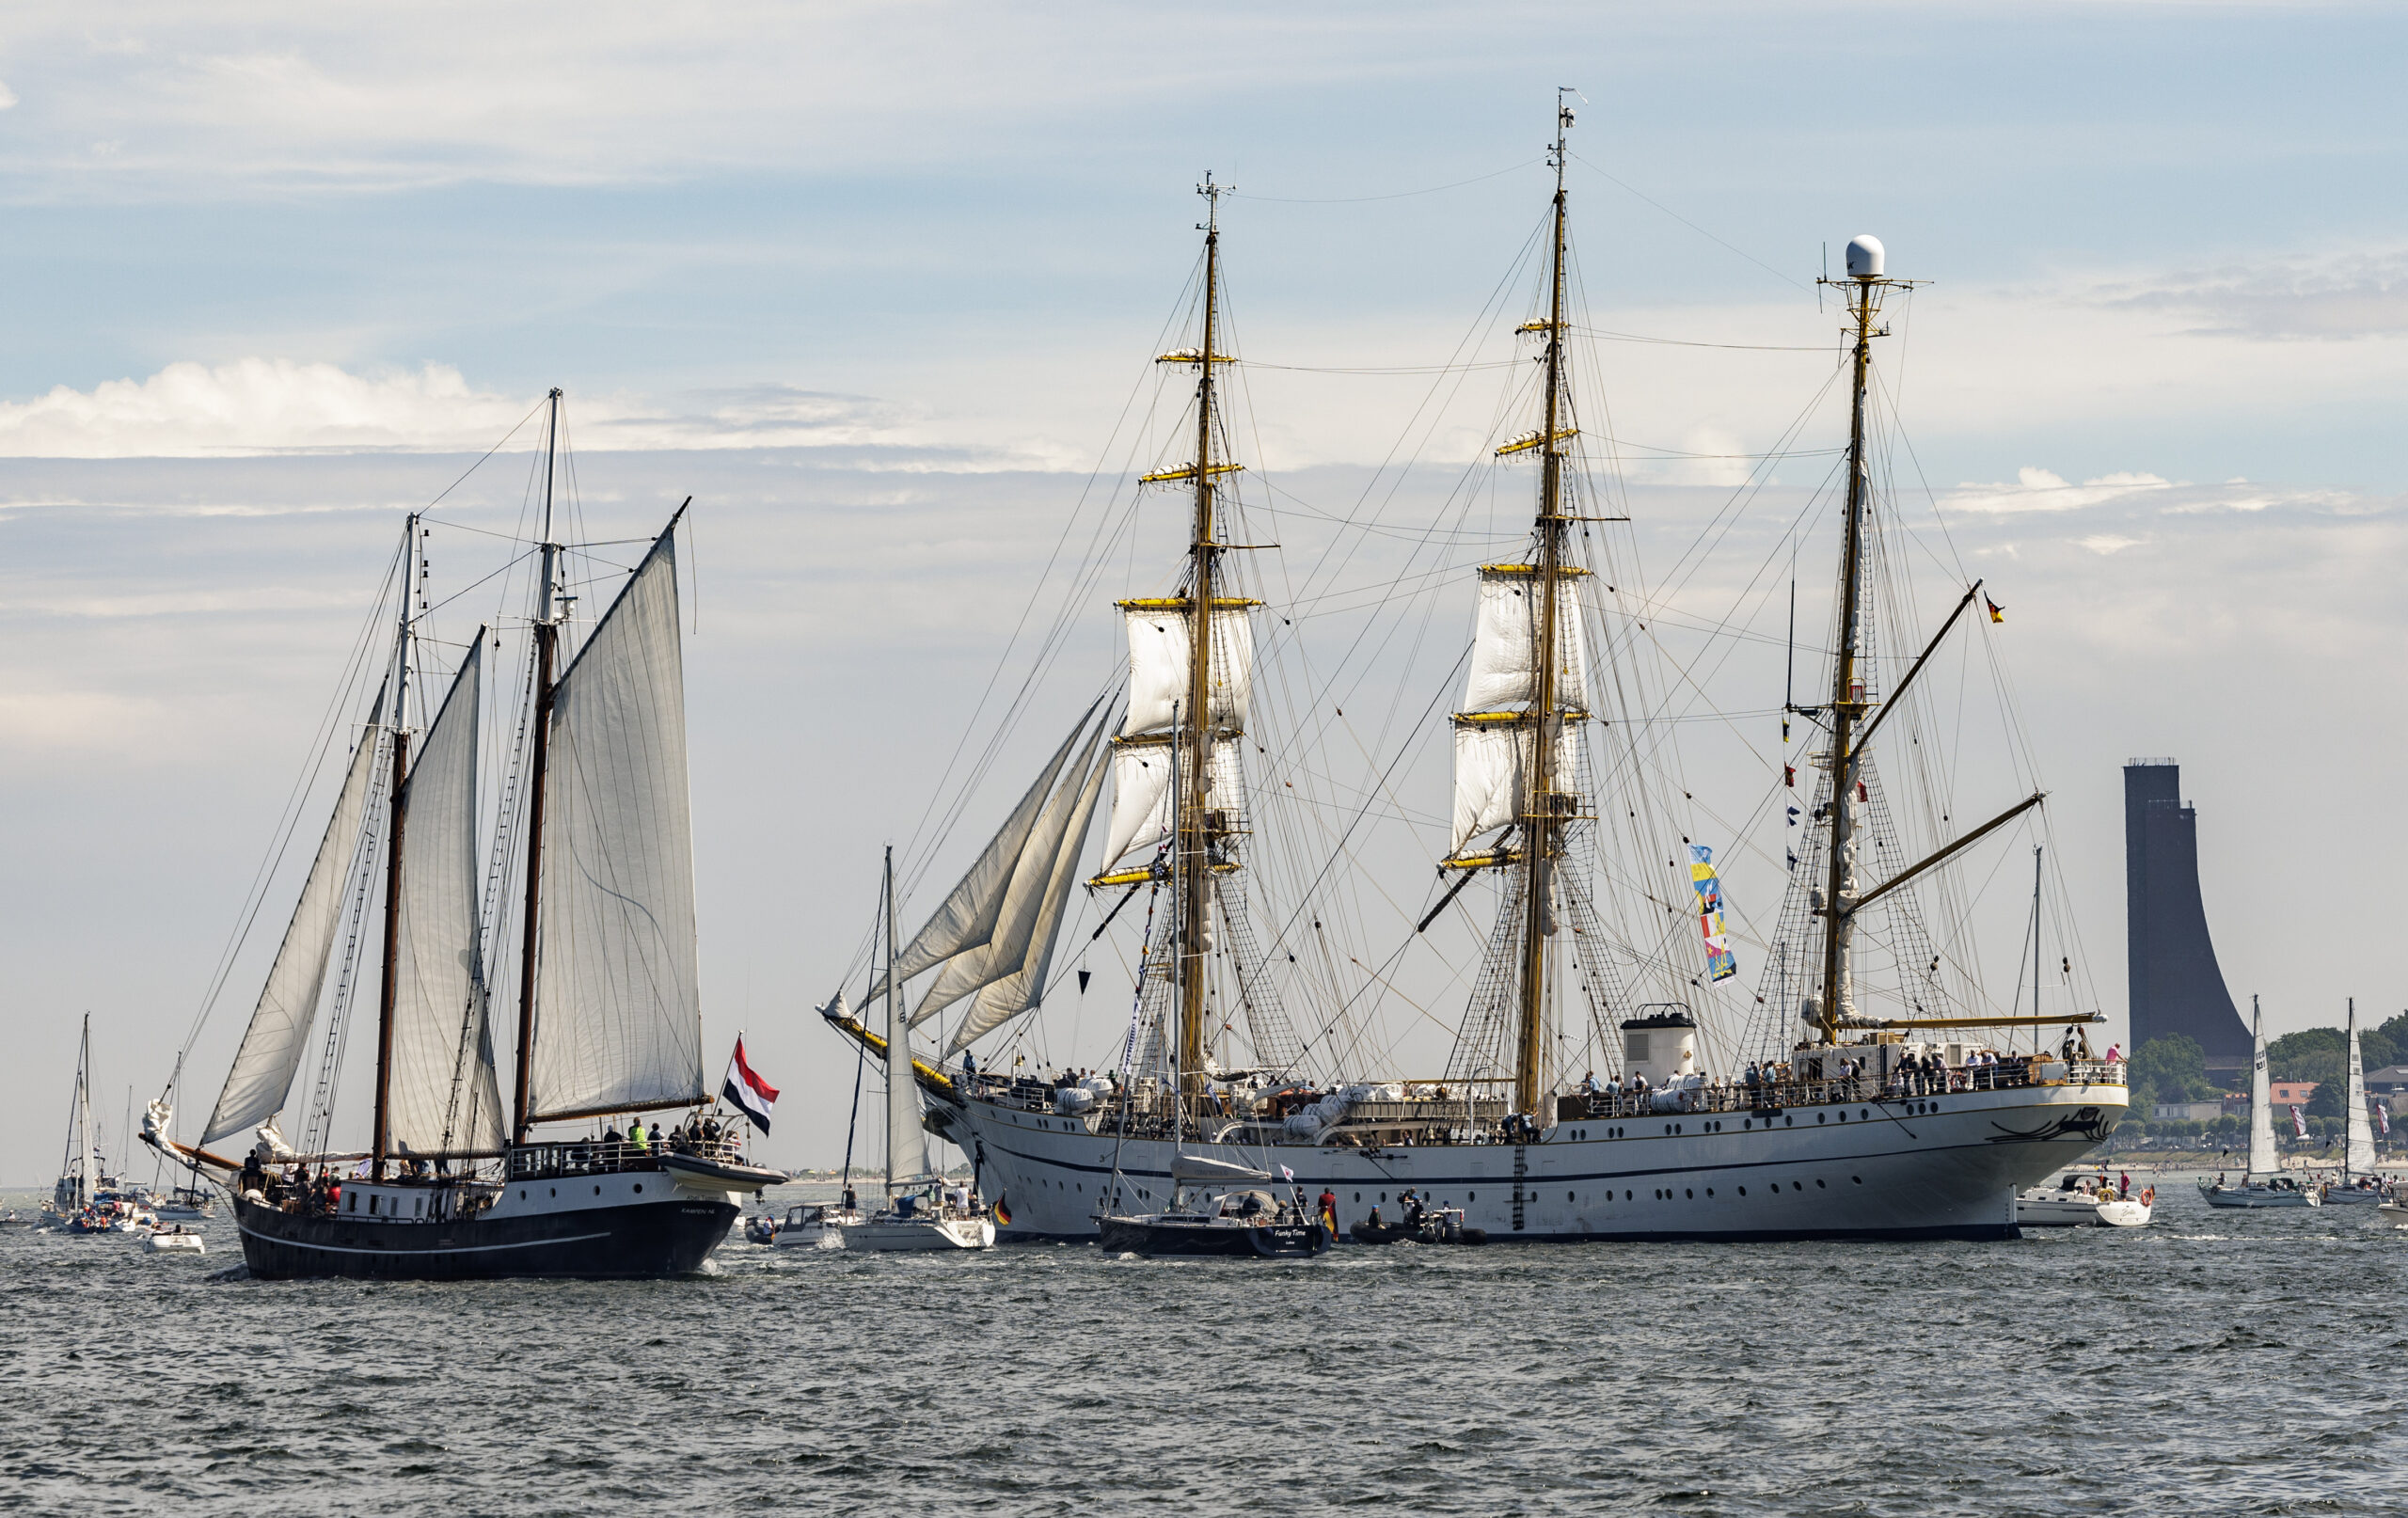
[0,3,2408,1180]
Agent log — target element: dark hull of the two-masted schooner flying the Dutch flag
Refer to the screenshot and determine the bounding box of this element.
[233,1197,737,1282]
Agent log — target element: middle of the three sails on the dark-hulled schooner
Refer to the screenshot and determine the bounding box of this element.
[388,629,503,1154]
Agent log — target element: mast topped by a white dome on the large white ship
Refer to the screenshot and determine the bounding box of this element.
[1814,239,1897,1043]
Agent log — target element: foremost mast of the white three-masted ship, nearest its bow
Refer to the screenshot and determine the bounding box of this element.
[1178,173,1228,1103]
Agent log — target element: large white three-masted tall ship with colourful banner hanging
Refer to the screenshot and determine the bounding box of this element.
[824,102,2126,1241]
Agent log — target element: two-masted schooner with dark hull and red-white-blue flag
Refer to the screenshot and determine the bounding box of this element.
[145,390,783,1279]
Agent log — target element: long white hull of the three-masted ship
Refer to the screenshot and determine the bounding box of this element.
[944,1084,2126,1243]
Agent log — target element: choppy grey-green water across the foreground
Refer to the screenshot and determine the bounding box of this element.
[0,1183,2408,1515]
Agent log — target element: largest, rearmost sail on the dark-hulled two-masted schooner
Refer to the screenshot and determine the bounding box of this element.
[528,532,705,1118]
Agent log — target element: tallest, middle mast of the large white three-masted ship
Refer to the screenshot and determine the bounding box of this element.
[1513,89,1573,1114]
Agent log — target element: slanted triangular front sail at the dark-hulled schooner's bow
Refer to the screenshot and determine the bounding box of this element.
[199,725,380,1146]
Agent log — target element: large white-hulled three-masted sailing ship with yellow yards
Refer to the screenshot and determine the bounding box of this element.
[824,103,2126,1241]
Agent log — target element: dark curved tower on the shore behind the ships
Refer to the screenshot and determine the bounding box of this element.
[2124,759,2249,1084]
